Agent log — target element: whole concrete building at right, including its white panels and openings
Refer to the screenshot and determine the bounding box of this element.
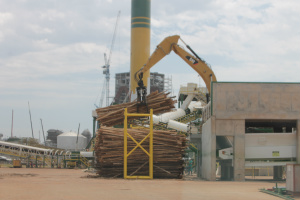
[200,82,300,181]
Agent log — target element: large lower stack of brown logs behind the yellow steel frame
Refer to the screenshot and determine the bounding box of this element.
[95,127,186,178]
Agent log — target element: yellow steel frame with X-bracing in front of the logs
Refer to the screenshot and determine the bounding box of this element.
[124,108,153,179]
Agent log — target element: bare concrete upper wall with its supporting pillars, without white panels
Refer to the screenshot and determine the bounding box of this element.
[202,82,300,181]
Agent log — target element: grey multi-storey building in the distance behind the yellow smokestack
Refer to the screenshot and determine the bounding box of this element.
[114,72,166,104]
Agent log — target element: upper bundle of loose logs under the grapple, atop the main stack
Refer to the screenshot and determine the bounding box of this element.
[96,91,176,126]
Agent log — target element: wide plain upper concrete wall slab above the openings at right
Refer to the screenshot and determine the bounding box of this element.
[212,82,300,119]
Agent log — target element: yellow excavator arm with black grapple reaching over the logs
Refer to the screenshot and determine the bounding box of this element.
[135,35,217,105]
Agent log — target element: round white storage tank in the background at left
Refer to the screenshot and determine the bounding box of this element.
[57,132,87,150]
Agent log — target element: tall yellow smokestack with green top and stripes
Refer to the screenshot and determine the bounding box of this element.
[130,0,151,101]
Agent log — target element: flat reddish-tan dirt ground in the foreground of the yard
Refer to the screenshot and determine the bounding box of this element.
[0,168,296,200]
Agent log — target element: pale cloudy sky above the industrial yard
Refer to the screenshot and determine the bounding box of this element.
[0,0,300,140]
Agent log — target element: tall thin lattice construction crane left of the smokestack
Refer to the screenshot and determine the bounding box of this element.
[99,11,121,107]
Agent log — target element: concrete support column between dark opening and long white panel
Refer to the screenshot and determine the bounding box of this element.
[233,120,245,181]
